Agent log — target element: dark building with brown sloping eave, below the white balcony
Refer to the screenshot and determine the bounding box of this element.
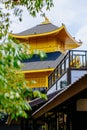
[32,74,87,130]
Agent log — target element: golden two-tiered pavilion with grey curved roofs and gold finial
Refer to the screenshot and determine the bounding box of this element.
[10,17,81,90]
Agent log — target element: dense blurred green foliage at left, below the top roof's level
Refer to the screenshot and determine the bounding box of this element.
[0,40,46,119]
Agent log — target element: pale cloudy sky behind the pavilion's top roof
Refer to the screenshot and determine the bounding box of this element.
[11,0,87,49]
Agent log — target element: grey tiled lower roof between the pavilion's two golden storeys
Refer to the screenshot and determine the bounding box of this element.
[22,52,65,70]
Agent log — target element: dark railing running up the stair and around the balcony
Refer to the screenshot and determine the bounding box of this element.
[48,50,87,88]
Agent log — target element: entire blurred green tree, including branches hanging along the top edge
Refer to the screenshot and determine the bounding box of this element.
[0,0,53,120]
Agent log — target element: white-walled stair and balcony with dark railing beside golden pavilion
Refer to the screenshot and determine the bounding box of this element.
[47,50,87,93]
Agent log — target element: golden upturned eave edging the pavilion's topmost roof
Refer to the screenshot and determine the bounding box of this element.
[9,25,81,49]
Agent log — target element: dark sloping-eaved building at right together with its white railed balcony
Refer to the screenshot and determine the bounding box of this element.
[31,50,87,130]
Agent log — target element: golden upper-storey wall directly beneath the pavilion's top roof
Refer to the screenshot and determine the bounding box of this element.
[19,36,65,52]
